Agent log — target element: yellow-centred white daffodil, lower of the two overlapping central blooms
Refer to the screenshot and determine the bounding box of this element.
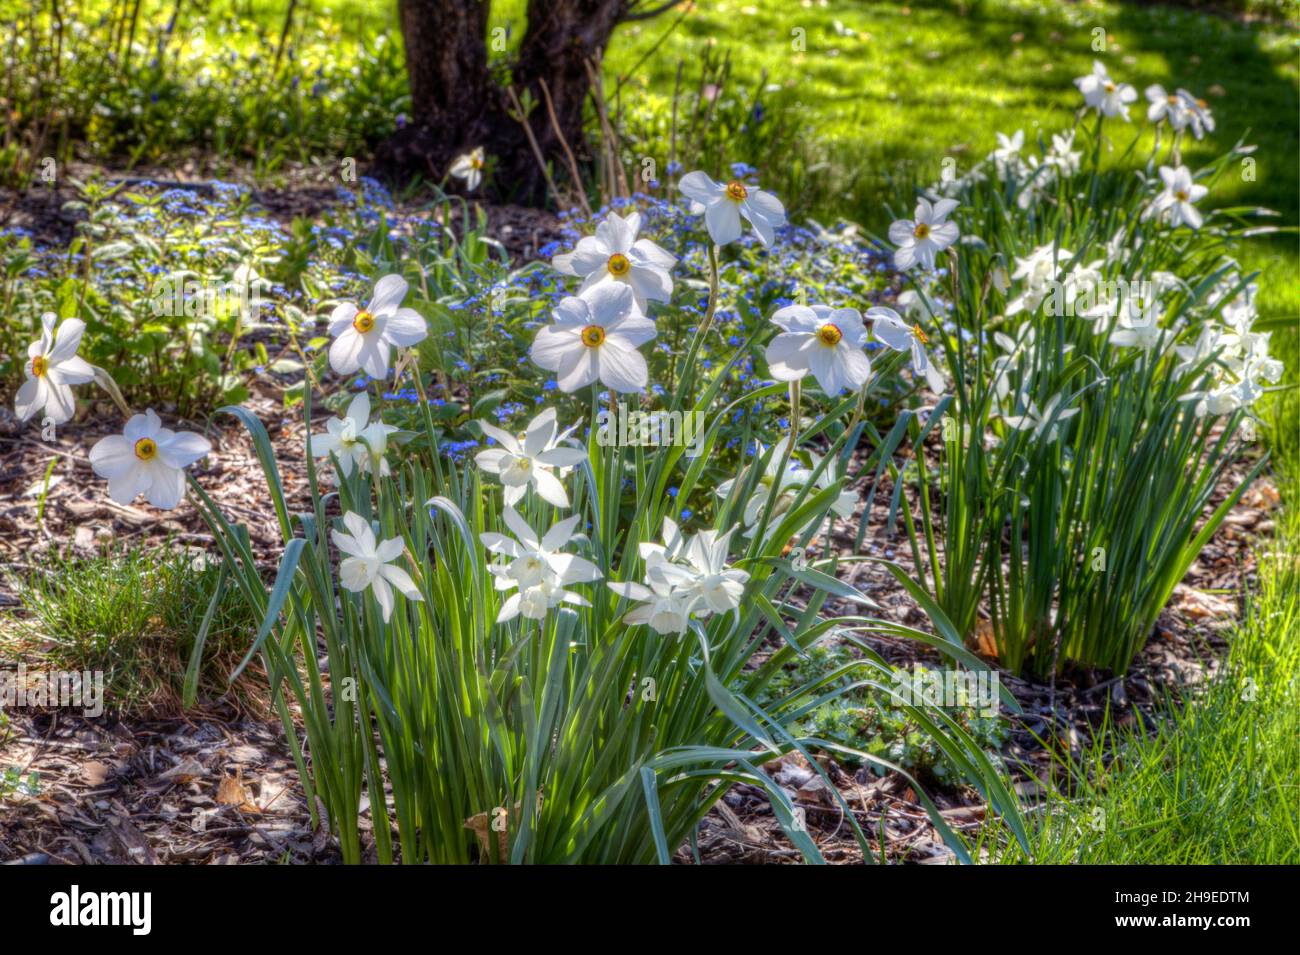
[529,282,657,392]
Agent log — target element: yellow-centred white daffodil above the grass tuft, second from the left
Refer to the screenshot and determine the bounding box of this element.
[90,408,212,511]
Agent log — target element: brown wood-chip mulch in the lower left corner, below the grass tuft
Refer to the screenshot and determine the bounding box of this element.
[0,708,338,865]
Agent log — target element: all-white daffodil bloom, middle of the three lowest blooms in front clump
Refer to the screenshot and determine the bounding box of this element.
[478,507,601,624]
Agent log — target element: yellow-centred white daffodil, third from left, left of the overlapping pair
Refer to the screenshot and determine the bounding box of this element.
[329,275,429,378]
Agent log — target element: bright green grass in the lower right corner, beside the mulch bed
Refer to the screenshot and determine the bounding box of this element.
[982,478,1300,864]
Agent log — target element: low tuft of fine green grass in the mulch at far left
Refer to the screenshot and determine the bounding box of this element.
[0,547,264,716]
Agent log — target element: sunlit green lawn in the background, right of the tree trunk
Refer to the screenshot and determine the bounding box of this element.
[598,0,1300,324]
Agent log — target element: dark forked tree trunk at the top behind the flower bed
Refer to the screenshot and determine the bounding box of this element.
[374,0,675,205]
